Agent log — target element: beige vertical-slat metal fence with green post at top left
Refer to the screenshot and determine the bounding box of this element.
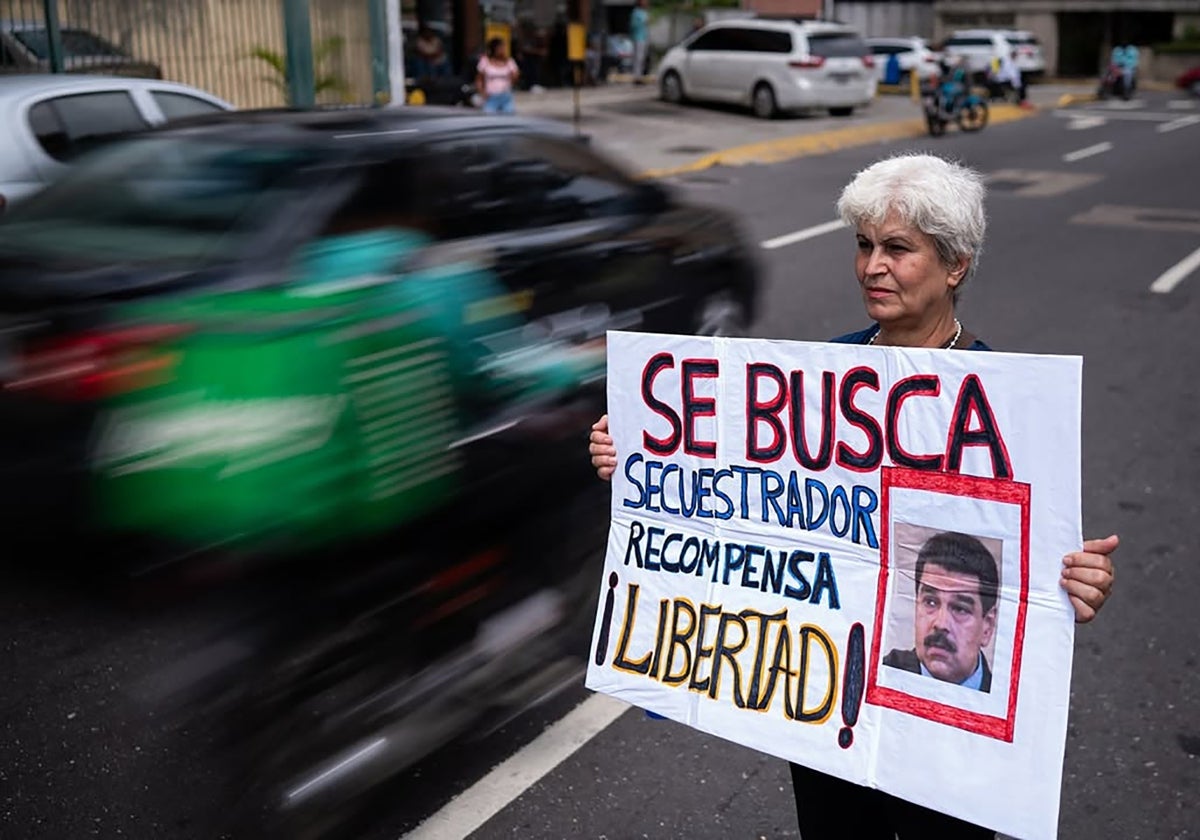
[0,0,388,108]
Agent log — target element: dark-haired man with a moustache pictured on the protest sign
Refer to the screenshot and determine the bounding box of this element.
[883,532,1000,691]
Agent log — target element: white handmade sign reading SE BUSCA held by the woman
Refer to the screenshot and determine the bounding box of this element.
[587,332,1082,839]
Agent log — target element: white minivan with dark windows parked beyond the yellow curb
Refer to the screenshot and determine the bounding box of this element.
[659,18,878,119]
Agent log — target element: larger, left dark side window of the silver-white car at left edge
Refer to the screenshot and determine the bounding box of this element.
[29,91,149,163]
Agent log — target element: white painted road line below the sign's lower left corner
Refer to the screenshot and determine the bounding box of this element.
[401,694,631,840]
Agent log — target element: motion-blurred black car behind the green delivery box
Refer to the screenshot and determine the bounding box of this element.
[0,102,757,565]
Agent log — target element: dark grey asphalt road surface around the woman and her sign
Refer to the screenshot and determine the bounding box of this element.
[0,94,1200,840]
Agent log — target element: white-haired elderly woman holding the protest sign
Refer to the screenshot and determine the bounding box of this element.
[588,155,1117,840]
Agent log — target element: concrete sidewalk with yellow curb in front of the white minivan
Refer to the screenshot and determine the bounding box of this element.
[506,79,1093,178]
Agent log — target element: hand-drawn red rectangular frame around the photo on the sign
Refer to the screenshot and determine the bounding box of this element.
[866,467,1030,743]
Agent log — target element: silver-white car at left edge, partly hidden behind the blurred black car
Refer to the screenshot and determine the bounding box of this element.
[0,73,233,209]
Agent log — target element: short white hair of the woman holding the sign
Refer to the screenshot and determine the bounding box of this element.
[838,154,988,298]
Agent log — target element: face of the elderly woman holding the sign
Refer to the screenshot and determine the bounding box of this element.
[854,212,967,329]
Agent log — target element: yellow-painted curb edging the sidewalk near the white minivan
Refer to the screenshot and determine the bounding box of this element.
[640,104,1038,180]
